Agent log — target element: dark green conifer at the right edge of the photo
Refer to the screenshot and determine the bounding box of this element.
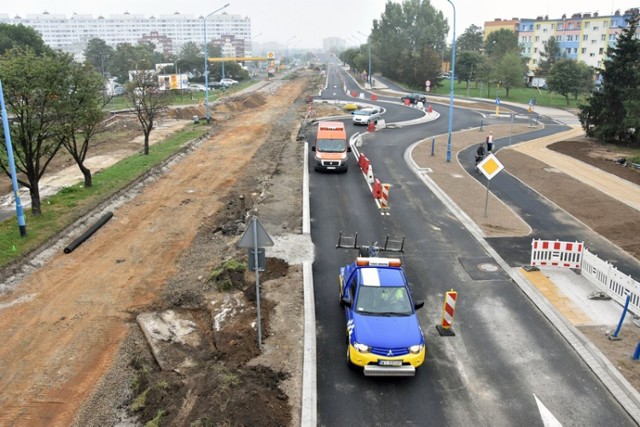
[578,10,640,146]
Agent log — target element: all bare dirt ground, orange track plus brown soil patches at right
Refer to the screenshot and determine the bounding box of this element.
[0,73,640,426]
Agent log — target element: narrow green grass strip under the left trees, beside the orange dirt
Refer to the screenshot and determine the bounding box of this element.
[0,125,208,268]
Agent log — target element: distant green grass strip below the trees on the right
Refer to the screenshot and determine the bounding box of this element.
[423,80,583,108]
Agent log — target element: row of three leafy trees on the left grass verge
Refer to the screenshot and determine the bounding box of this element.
[0,24,171,215]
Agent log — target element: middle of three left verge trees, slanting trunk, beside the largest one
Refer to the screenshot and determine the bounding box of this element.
[58,63,105,188]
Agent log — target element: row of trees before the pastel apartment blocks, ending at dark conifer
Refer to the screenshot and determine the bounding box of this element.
[339,0,640,144]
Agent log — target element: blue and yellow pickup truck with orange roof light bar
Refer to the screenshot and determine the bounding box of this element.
[339,256,426,376]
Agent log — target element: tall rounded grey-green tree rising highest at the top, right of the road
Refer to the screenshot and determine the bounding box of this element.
[369,0,449,87]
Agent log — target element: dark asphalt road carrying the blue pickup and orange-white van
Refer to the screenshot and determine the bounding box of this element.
[307,63,635,426]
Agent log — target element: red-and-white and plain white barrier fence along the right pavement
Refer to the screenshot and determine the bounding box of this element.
[531,239,640,316]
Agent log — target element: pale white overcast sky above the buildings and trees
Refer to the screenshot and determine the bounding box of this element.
[6,0,640,48]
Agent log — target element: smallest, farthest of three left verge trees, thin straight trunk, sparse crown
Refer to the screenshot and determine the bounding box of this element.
[126,70,167,155]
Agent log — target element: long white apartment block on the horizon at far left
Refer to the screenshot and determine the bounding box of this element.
[0,12,251,55]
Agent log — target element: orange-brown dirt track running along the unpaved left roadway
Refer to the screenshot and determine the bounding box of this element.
[0,72,308,426]
